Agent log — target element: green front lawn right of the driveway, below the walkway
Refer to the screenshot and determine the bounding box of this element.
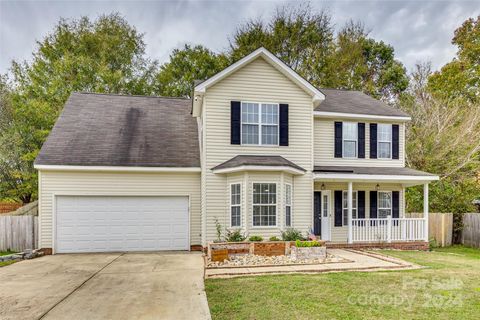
[205,247,480,320]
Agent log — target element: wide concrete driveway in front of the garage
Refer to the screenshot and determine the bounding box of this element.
[0,252,210,319]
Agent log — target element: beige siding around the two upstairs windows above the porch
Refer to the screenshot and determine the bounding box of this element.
[314,118,405,167]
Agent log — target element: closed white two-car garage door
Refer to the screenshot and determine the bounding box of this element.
[55,196,189,253]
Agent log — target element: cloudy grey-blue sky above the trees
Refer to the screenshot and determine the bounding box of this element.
[0,0,480,73]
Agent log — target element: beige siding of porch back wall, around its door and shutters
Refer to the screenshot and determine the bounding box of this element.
[315,182,405,242]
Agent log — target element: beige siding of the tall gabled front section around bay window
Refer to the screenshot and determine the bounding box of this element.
[202,58,313,244]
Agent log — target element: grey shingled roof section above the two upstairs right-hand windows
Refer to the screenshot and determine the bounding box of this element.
[315,89,410,117]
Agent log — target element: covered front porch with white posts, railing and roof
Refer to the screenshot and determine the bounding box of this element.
[313,167,438,247]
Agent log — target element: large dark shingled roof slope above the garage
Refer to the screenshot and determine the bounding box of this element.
[35,93,200,167]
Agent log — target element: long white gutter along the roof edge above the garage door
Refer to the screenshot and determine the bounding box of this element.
[33,164,201,173]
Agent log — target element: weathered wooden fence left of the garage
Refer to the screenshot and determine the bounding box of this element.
[0,215,38,251]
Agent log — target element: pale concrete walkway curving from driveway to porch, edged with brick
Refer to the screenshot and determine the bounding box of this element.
[205,249,420,278]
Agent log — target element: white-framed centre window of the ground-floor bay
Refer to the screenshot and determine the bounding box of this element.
[253,183,277,227]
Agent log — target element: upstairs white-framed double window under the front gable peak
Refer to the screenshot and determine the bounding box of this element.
[241,102,279,146]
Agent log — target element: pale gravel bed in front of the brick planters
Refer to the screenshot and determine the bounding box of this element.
[207,253,351,268]
